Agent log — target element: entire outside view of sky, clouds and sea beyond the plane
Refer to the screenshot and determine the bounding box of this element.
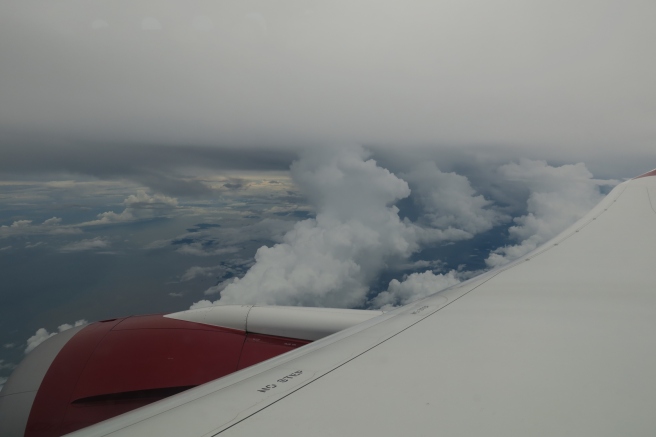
[0,0,656,385]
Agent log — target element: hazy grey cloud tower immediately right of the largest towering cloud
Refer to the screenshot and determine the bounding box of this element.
[401,162,510,239]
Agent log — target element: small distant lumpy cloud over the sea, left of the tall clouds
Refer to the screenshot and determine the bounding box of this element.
[80,190,178,226]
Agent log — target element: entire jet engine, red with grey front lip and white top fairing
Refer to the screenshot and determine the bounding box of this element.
[0,306,381,437]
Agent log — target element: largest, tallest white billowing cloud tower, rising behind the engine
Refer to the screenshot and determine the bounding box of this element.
[199,147,418,307]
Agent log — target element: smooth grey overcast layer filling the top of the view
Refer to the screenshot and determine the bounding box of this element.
[0,0,656,169]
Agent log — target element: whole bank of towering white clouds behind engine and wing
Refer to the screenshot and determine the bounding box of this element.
[188,150,615,308]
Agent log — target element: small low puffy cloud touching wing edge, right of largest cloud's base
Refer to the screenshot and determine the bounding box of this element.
[370,270,460,311]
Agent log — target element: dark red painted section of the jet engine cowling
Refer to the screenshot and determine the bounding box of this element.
[9,315,309,437]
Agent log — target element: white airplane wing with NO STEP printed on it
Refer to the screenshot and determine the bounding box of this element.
[21,171,656,437]
